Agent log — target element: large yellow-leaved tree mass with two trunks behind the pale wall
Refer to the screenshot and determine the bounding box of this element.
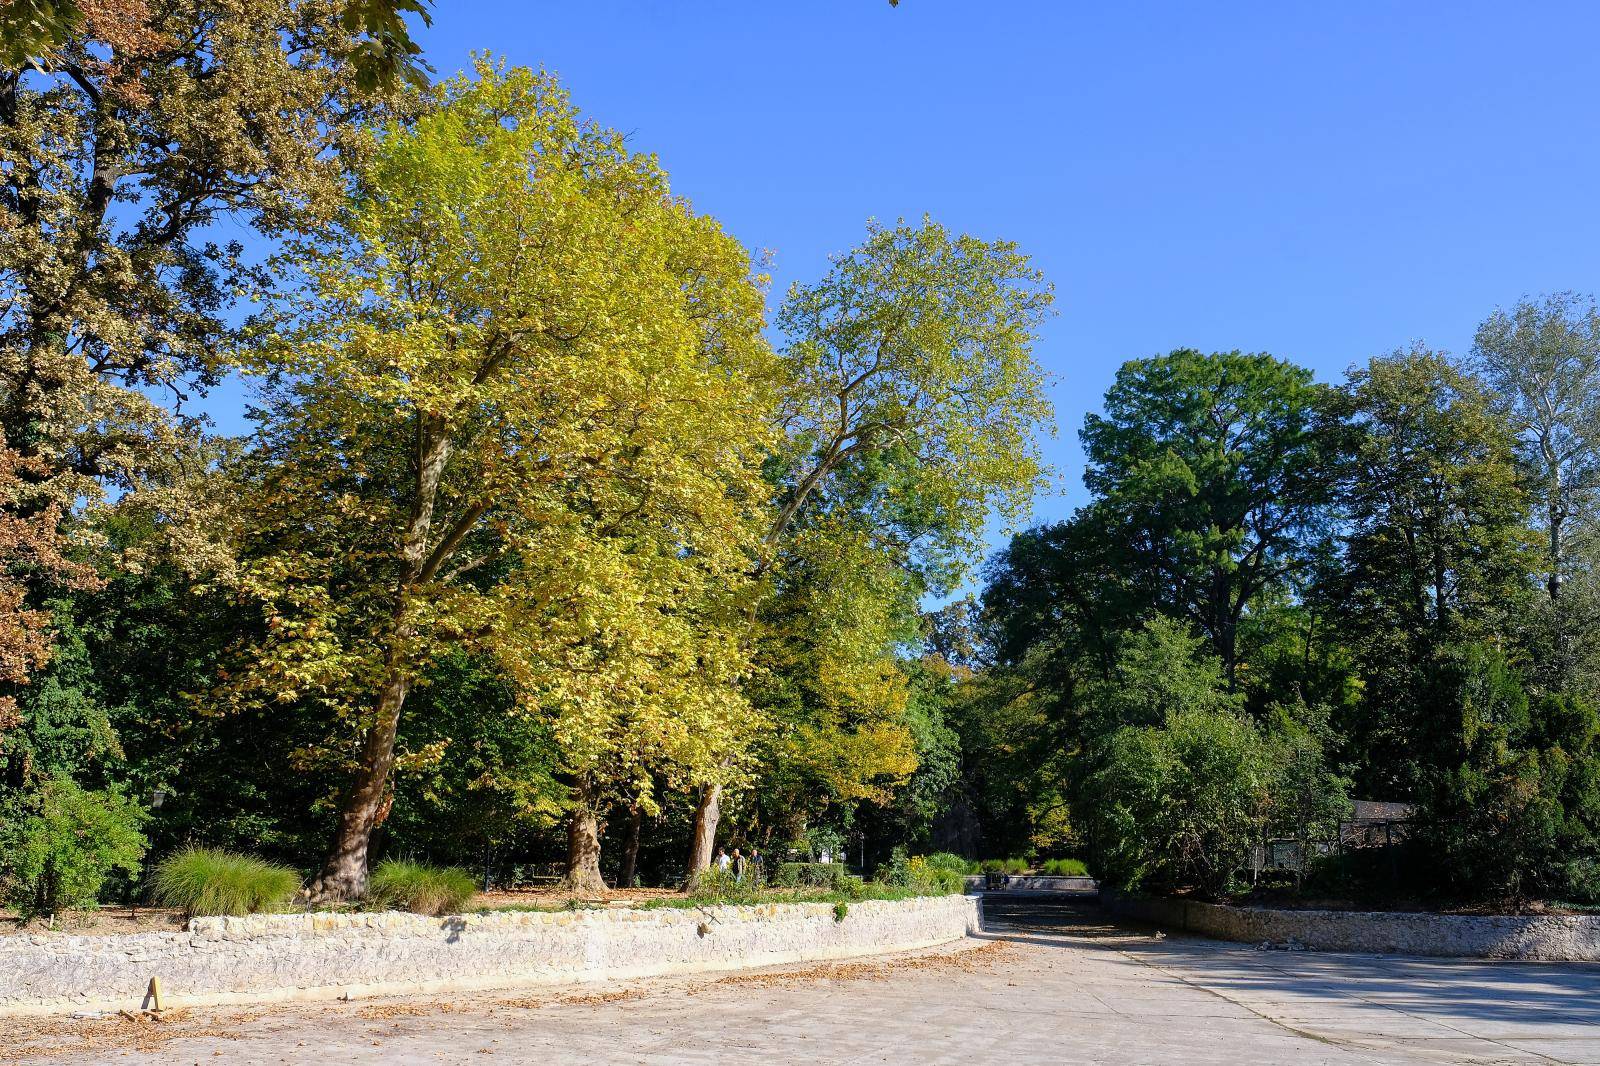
[227,61,771,898]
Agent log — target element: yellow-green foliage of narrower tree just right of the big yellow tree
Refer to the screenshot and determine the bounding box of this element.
[750,219,1051,842]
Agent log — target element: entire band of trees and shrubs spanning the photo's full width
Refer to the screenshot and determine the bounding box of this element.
[0,0,1600,914]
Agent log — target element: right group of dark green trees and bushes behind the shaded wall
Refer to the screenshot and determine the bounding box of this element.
[960,312,1600,901]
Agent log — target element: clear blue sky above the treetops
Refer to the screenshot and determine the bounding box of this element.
[206,0,1600,557]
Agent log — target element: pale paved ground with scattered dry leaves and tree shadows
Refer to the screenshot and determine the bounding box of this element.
[12,896,1600,1066]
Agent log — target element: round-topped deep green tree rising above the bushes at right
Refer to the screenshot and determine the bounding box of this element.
[1082,349,1339,683]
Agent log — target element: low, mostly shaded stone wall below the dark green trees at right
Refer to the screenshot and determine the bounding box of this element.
[1101,892,1600,962]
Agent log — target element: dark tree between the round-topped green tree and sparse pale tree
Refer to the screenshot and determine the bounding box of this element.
[1328,347,1534,795]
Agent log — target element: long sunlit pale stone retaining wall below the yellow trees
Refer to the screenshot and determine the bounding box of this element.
[0,896,978,1013]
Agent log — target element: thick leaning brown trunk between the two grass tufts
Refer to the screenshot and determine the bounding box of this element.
[307,415,459,903]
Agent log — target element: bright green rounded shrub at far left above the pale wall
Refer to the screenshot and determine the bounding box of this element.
[0,778,149,920]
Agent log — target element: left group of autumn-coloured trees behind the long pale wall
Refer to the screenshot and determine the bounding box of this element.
[0,0,1051,912]
